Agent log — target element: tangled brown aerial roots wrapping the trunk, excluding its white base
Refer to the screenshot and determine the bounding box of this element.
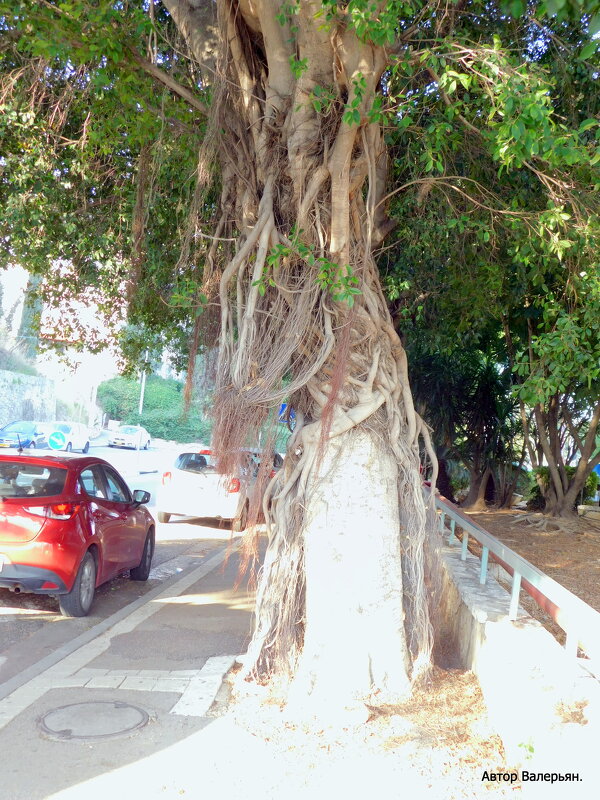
[204,2,435,692]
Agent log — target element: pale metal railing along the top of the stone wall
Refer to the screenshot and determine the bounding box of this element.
[425,487,600,659]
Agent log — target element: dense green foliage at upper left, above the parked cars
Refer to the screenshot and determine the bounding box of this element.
[0,1,210,367]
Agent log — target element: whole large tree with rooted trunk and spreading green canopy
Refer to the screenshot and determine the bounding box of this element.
[0,0,597,710]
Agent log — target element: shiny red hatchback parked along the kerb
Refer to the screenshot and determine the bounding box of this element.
[0,452,154,617]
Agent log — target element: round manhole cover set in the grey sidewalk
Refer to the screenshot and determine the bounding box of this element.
[39,701,148,741]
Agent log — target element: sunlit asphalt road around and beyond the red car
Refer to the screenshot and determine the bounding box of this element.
[0,434,239,682]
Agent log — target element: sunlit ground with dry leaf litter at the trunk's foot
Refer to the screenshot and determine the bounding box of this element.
[213,667,520,800]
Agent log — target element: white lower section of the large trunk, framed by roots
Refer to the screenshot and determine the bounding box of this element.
[290,431,409,709]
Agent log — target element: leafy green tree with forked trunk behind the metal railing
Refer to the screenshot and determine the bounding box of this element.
[381,15,600,515]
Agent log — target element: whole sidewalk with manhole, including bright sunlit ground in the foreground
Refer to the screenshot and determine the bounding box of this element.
[0,542,597,800]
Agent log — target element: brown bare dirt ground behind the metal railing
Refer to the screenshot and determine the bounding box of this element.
[469,509,600,644]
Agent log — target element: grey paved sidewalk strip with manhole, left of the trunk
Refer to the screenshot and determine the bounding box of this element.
[0,543,253,800]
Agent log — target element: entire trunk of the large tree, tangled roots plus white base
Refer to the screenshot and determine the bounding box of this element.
[168,0,435,703]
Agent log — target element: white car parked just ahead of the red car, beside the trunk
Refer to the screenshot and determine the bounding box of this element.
[156,449,282,531]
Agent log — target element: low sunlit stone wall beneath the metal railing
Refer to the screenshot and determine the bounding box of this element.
[434,546,600,790]
